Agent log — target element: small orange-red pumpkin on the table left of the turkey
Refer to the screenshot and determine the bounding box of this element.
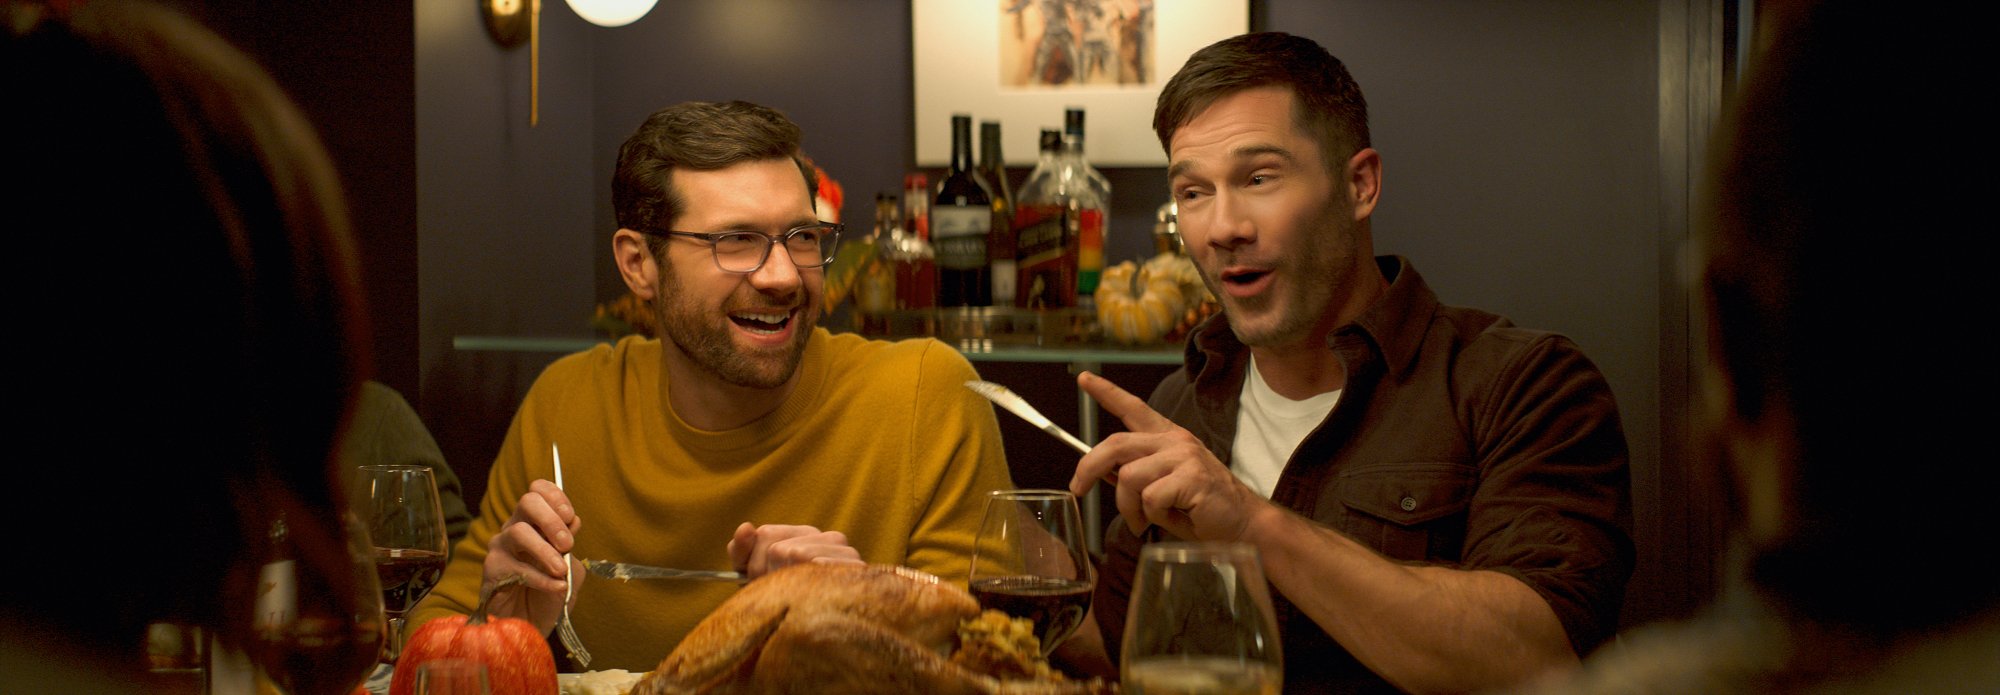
[388,575,560,695]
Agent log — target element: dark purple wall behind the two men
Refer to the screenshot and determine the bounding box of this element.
[410,0,1716,621]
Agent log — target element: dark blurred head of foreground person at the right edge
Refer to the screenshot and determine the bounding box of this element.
[1702,2,2000,639]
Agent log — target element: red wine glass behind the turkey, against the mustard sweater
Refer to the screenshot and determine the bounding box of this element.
[970,489,1096,657]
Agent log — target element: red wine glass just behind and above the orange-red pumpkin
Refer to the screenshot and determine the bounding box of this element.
[354,465,448,663]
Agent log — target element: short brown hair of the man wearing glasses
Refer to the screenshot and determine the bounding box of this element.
[612,102,818,254]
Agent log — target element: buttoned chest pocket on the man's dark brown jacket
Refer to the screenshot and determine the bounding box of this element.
[1320,461,1478,561]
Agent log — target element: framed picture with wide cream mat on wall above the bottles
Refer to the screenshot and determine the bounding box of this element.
[910,0,1250,168]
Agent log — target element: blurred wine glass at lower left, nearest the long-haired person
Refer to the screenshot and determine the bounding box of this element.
[252,513,384,695]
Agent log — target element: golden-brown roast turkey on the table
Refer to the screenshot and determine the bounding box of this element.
[632,565,1116,695]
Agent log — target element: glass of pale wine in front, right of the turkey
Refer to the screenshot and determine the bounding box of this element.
[1120,543,1284,695]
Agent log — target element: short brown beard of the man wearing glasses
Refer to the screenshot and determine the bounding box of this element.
[654,260,820,389]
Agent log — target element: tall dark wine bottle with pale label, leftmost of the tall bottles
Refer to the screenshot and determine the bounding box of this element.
[930,114,994,306]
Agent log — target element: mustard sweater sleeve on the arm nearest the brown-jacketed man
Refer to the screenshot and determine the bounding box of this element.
[904,342,1014,585]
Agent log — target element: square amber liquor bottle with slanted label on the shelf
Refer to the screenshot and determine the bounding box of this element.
[1014,130,1104,310]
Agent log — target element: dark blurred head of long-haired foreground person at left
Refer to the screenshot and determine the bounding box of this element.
[0,0,368,677]
